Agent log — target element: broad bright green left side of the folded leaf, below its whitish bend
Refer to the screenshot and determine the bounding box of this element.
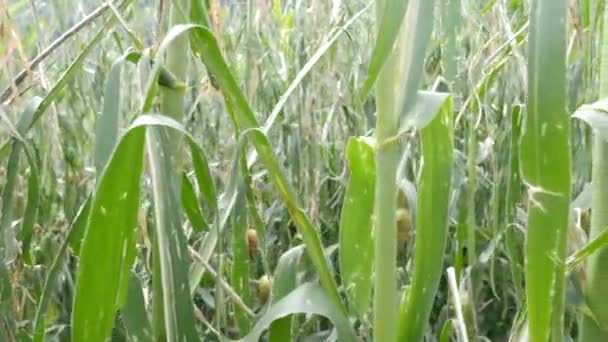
[72,124,145,342]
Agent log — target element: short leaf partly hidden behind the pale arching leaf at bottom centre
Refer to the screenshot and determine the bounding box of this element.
[268,245,304,342]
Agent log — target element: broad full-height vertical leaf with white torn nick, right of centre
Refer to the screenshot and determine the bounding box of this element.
[521,0,571,341]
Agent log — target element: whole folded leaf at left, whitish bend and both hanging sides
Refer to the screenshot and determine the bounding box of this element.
[72,115,207,341]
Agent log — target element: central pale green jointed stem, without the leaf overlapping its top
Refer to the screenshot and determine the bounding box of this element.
[374,0,405,342]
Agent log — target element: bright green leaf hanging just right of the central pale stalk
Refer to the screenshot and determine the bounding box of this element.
[398,98,454,341]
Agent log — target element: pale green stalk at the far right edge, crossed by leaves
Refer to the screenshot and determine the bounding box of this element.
[580,2,608,342]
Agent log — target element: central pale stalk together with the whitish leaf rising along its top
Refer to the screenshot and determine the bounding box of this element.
[364,0,434,341]
